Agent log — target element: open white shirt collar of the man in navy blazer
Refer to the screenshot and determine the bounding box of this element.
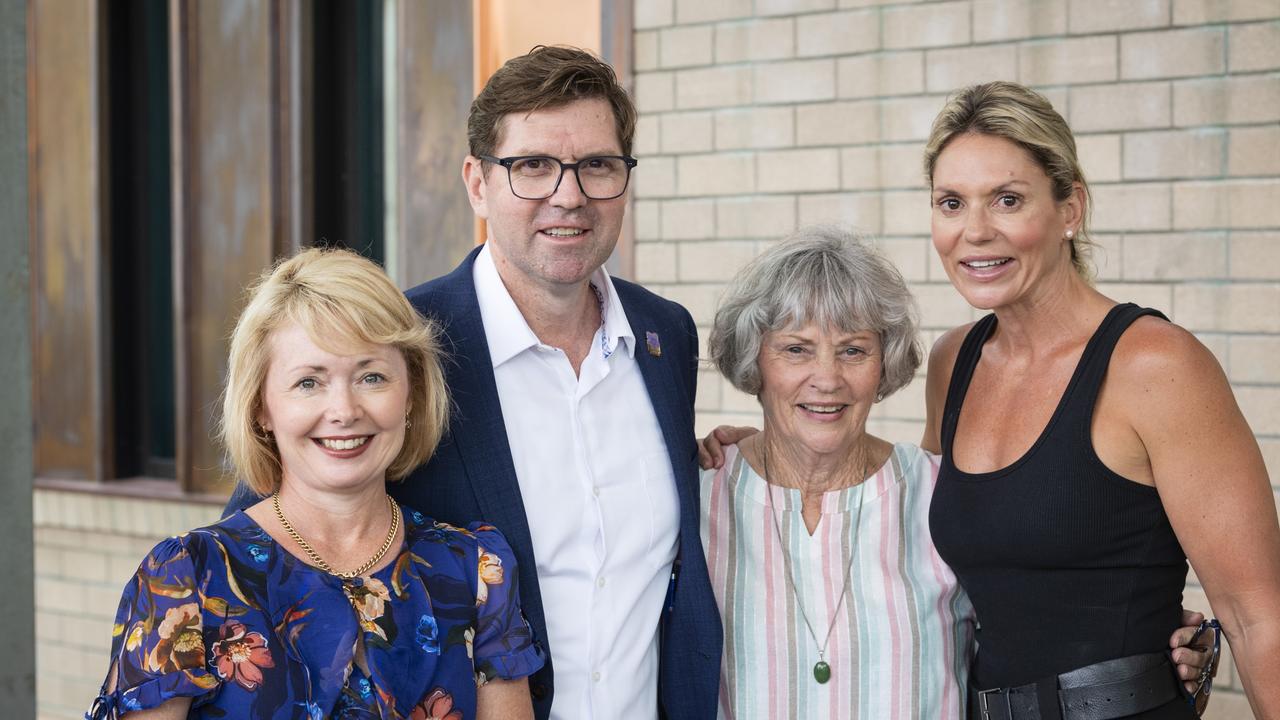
[471,243,635,368]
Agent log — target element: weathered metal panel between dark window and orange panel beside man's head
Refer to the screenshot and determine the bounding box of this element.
[388,0,475,287]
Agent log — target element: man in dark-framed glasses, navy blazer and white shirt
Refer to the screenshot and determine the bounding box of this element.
[393,47,722,720]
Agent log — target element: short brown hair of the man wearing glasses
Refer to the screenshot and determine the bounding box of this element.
[467,45,636,158]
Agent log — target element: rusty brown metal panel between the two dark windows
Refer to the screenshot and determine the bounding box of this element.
[170,0,290,492]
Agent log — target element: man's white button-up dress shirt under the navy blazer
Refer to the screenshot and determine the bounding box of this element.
[472,247,680,720]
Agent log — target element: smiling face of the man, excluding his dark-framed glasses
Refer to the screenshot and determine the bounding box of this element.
[462,99,627,291]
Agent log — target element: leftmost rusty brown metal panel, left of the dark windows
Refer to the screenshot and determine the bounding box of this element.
[27,0,111,480]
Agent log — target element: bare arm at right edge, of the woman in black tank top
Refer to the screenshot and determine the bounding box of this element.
[1112,323,1280,717]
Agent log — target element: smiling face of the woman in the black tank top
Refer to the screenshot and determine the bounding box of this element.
[932,133,1084,310]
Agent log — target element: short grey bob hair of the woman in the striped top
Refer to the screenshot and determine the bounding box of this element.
[707,225,924,401]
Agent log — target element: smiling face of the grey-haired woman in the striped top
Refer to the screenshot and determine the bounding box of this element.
[759,325,883,455]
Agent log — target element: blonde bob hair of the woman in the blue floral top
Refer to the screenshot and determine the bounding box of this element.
[219,247,449,496]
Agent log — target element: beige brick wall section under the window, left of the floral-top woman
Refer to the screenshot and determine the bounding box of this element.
[33,489,221,720]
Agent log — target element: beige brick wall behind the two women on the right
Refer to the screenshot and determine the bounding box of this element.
[635,0,1280,719]
